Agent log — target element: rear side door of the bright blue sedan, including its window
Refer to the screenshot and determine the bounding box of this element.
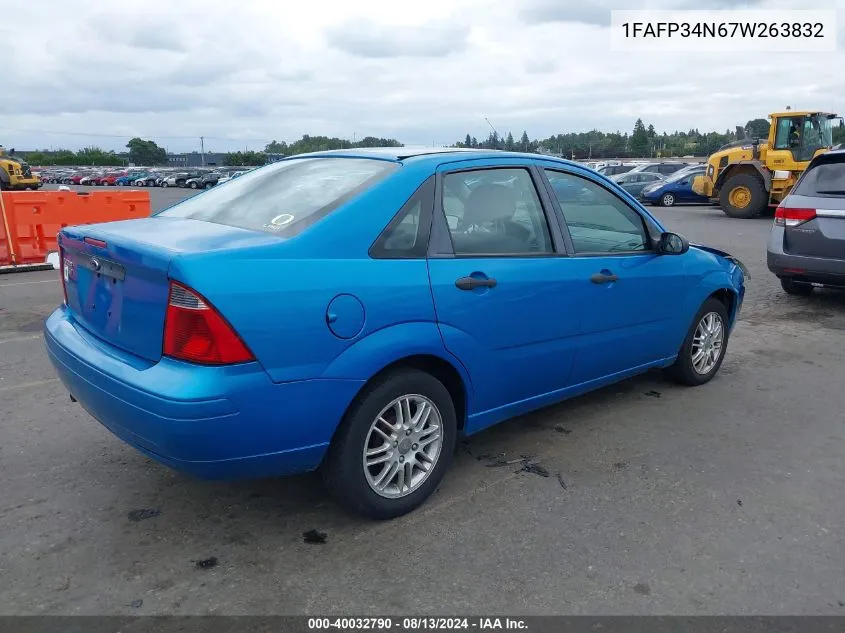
[428,159,579,431]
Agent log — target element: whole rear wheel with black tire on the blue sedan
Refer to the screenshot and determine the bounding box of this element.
[322,370,457,519]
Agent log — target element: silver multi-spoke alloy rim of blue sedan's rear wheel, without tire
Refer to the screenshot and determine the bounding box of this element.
[363,395,443,499]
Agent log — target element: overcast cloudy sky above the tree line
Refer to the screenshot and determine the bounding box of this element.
[0,0,845,151]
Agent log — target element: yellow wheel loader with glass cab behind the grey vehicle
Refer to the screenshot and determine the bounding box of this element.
[692,108,841,218]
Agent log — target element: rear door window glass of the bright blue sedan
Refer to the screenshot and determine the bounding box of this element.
[443,168,554,255]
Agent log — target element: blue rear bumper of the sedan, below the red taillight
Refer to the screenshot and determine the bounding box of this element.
[44,308,363,479]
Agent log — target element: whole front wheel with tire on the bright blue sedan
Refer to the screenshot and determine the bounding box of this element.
[669,297,728,387]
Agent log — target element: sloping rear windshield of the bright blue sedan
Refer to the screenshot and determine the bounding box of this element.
[158,158,397,236]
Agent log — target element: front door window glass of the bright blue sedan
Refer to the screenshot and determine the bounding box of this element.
[546,170,651,254]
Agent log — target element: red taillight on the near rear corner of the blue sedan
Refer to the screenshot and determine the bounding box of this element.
[163,281,255,365]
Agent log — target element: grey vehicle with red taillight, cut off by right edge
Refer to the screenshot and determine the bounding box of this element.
[766,150,845,295]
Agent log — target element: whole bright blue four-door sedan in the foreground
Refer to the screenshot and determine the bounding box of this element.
[44,148,745,519]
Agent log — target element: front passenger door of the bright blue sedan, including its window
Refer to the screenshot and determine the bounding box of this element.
[543,168,688,384]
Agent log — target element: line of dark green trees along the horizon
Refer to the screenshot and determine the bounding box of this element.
[16,119,845,167]
